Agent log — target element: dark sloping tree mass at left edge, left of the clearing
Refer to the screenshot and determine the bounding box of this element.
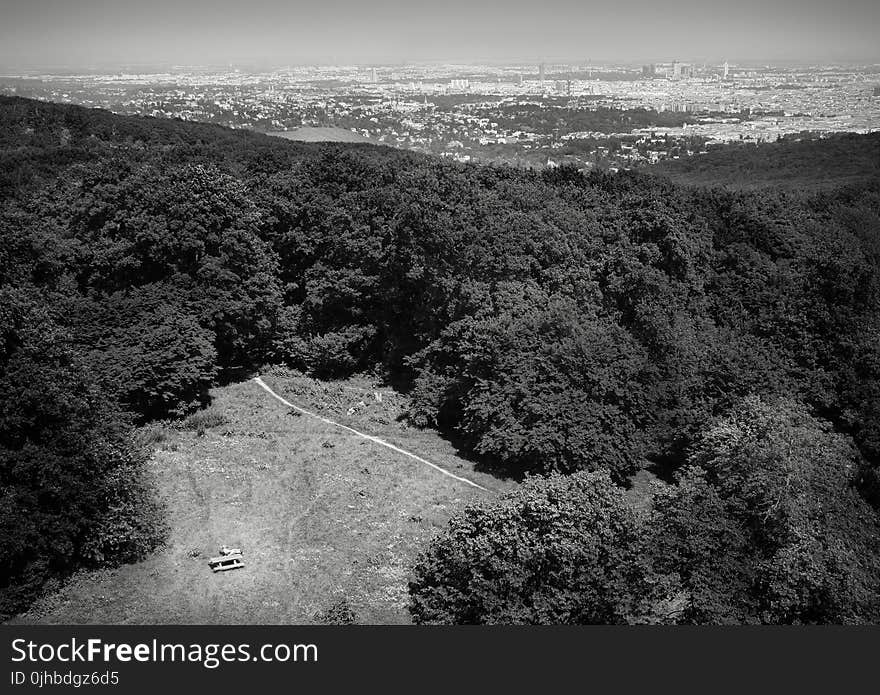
[0,289,164,617]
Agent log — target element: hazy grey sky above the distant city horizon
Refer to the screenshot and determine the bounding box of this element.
[0,0,880,67]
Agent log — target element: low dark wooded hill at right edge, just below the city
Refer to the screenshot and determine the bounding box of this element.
[649,133,880,190]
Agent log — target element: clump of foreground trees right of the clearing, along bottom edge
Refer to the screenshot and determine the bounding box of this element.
[410,397,880,624]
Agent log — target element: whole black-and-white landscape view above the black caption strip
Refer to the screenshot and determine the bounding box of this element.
[0,0,880,626]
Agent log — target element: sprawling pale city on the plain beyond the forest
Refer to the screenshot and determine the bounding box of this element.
[0,61,880,170]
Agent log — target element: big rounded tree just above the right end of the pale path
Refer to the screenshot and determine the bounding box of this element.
[415,285,645,480]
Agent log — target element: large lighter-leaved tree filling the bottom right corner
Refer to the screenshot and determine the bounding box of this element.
[645,397,880,624]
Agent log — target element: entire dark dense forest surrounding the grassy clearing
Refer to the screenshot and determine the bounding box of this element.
[0,97,880,624]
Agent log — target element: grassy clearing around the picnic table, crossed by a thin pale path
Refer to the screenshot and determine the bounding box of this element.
[11,375,514,624]
